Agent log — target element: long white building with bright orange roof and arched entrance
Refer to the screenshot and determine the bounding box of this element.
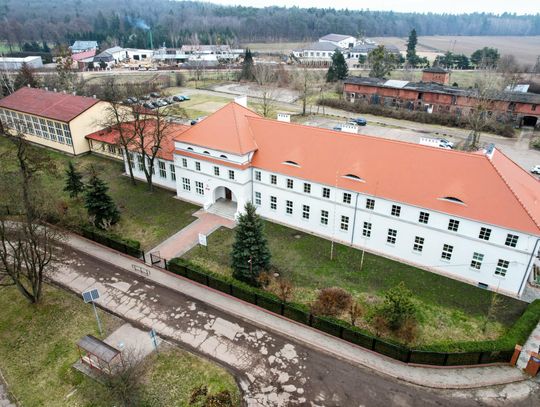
[110,103,540,295]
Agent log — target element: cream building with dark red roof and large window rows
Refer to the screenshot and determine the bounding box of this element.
[0,88,108,155]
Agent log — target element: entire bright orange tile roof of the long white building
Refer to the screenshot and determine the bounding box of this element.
[177,103,540,235]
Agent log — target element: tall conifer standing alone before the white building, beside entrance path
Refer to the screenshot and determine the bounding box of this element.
[231,202,270,286]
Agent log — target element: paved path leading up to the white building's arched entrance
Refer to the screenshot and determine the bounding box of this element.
[150,209,234,259]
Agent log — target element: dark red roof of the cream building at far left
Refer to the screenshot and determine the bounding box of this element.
[0,88,99,123]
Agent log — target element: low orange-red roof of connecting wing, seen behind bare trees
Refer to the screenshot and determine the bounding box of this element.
[86,119,190,161]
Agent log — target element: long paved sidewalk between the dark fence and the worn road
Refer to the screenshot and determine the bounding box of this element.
[63,231,528,389]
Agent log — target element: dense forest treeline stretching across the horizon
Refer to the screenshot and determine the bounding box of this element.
[0,0,540,47]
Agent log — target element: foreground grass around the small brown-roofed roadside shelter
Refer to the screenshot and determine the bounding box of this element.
[0,285,239,407]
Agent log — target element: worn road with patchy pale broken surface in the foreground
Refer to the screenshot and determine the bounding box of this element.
[54,238,537,407]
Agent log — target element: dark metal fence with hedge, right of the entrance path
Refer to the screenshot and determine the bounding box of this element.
[164,261,513,366]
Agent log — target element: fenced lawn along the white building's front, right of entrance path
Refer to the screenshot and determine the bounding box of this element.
[185,222,526,345]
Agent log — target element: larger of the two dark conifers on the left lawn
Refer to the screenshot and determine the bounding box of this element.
[84,171,120,229]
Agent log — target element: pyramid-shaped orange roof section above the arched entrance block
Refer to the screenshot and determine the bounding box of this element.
[176,102,258,155]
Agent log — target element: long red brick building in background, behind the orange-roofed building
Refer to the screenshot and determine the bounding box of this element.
[343,68,540,128]
